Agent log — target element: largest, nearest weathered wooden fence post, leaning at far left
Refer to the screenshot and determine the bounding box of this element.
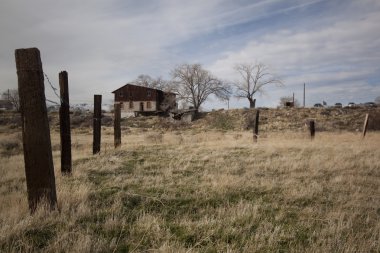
[15,48,57,213]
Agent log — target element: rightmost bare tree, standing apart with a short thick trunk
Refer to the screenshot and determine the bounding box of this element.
[234,63,282,108]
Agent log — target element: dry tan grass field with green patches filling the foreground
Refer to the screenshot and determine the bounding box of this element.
[0,111,380,252]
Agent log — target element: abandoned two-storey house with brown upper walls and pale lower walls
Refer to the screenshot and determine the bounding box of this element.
[112,84,177,114]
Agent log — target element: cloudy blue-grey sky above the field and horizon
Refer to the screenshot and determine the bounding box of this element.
[0,0,380,109]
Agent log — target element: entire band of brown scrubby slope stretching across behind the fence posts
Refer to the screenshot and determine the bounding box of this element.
[0,108,380,131]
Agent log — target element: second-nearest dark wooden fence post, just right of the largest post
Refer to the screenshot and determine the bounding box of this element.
[59,71,72,174]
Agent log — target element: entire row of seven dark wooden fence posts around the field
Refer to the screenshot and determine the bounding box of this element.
[15,48,368,213]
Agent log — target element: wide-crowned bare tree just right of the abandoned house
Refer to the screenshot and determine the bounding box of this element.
[172,64,230,112]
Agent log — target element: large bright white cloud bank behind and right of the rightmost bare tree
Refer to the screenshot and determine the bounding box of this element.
[210,5,380,105]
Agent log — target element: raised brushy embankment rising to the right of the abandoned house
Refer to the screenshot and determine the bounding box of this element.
[193,108,380,131]
